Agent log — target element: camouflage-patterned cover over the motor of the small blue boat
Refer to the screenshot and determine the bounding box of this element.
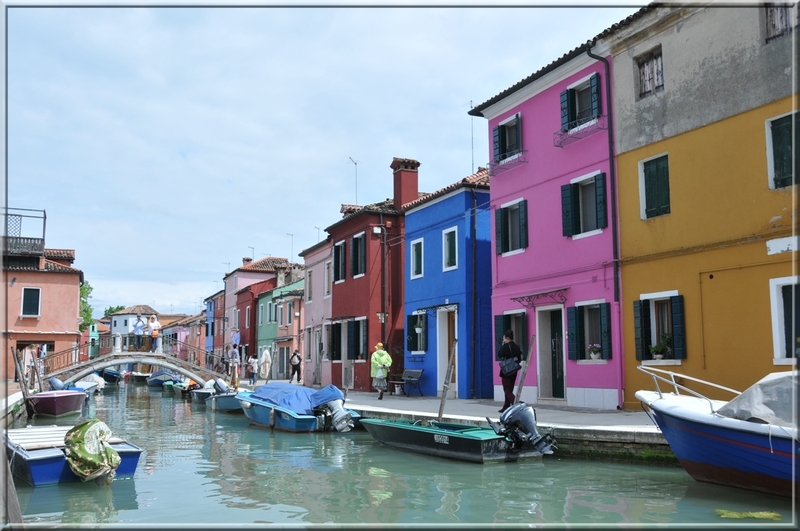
[64,419,122,483]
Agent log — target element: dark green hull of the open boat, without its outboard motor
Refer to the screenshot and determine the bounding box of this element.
[361,419,542,463]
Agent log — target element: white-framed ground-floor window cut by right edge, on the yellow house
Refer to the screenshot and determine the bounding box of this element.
[769,276,800,361]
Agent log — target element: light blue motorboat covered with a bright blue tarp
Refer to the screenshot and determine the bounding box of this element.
[236,382,360,433]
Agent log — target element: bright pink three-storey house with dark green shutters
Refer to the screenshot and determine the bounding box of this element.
[470,43,623,409]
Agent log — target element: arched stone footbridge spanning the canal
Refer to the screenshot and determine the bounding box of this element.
[43,352,226,385]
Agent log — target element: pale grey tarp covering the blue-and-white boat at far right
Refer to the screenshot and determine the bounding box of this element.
[717,371,797,428]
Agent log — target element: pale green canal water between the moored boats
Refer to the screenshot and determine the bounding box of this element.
[12,385,796,528]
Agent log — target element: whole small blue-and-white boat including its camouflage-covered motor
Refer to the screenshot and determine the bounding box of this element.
[5,419,142,487]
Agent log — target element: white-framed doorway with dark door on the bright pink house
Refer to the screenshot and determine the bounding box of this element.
[536,306,566,399]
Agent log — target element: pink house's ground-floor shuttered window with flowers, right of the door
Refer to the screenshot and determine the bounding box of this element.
[567,301,611,360]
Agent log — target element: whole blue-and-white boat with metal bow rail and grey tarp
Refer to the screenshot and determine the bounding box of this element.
[635,366,800,496]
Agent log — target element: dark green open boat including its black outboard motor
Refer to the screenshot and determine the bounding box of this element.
[361,402,556,463]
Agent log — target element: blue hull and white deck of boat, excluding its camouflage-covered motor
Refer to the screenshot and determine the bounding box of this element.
[6,426,142,487]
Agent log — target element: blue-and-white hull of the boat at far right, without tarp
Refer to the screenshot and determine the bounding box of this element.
[636,391,800,496]
